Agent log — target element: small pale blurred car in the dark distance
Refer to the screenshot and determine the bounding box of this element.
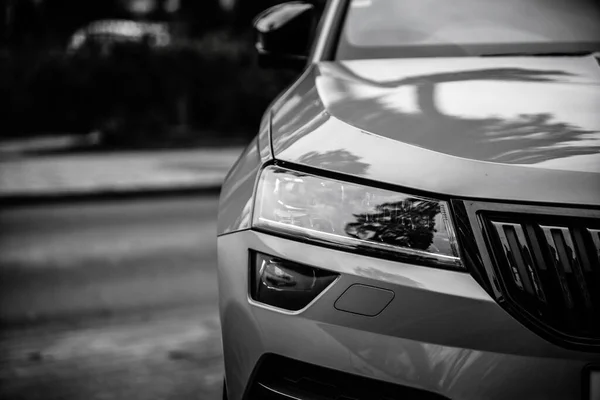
[67,20,172,54]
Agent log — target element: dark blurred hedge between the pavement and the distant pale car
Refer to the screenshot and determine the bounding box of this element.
[0,31,296,146]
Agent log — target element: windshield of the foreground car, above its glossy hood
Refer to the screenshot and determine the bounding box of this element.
[336,0,600,59]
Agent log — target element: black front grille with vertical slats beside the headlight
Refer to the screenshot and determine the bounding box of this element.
[483,213,600,346]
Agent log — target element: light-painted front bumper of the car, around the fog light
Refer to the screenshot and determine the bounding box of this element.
[218,230,600,400]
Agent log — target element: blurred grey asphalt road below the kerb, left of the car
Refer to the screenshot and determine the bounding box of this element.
[0,196,223,400]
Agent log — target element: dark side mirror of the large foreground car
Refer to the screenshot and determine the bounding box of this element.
[254,1,318,69]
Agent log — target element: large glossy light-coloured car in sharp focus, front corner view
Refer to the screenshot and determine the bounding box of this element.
[217,0,600,400]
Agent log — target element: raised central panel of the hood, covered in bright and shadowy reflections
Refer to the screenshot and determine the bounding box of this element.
[317,57,600,165]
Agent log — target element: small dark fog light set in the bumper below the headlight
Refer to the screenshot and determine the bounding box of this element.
[250,253,339,311]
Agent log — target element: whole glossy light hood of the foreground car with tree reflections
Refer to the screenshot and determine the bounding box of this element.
[271,56,600,205]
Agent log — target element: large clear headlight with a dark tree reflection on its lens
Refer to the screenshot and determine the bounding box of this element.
[252,166,463,269]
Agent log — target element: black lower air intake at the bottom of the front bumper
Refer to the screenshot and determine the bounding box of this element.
[246,354,448,400]
